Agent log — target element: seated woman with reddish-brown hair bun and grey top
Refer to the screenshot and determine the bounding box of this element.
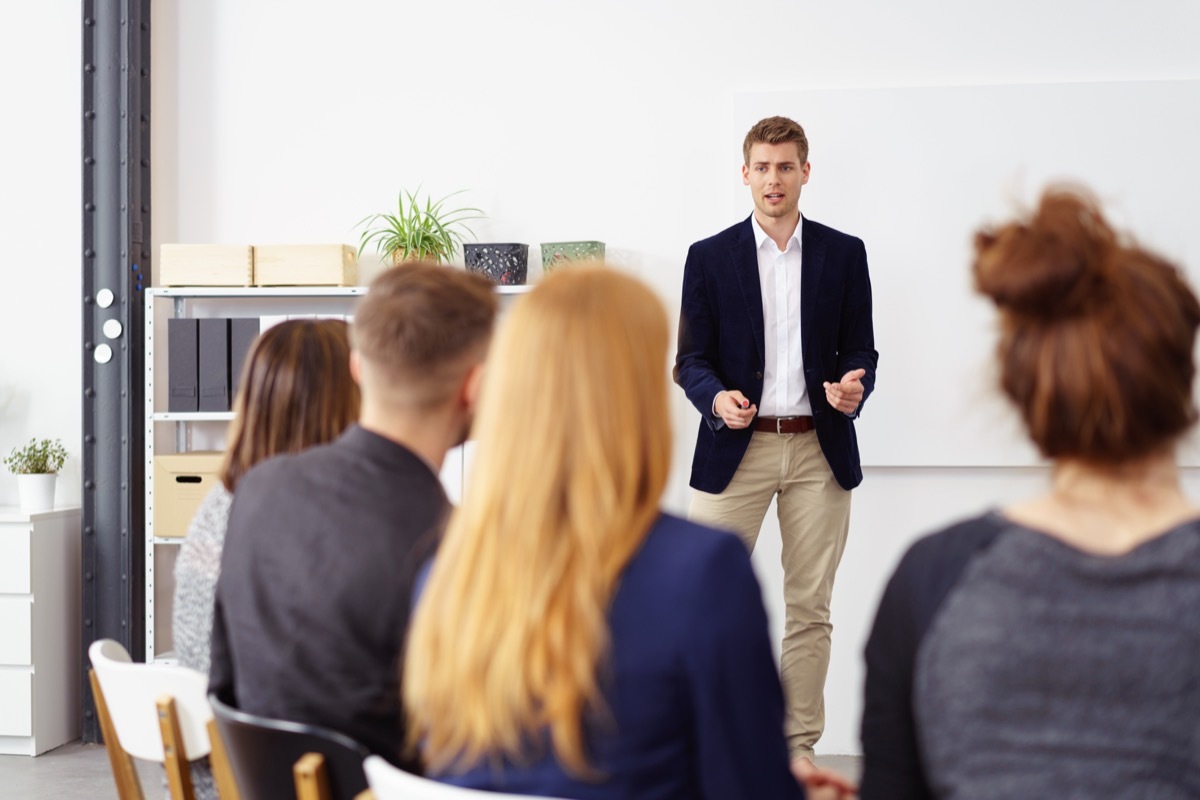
[862,188,1200,800]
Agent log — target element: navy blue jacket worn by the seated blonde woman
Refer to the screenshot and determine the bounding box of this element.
[436,515,804,800]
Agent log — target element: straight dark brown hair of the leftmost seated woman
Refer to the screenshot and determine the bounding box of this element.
[221,319,359,492]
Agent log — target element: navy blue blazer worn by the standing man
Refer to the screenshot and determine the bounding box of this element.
[673,217,880,494]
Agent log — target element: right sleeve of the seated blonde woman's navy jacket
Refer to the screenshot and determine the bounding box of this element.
[685,535,804,800]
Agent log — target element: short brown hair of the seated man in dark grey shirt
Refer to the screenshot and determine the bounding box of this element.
[350,261,497,405]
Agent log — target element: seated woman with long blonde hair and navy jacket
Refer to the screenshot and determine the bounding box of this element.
[403,267,854,800]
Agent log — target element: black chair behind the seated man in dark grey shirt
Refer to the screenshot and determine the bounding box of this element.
[209,694,370,800]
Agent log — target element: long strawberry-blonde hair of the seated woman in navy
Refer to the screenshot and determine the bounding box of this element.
[403,266,671,775]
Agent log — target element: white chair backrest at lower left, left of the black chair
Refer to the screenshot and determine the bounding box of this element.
[88,639,212,764]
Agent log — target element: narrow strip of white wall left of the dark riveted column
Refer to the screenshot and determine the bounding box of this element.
[0,0,83,505]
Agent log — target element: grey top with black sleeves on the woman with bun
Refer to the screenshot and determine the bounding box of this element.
[862,513,1200,800]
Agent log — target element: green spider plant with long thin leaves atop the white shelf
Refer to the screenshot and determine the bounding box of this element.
[356,188,484,264]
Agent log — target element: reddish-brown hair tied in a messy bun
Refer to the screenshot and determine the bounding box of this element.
[973,187,1200,465]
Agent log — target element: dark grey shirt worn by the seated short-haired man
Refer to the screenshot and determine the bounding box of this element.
[209,426,449,769]
